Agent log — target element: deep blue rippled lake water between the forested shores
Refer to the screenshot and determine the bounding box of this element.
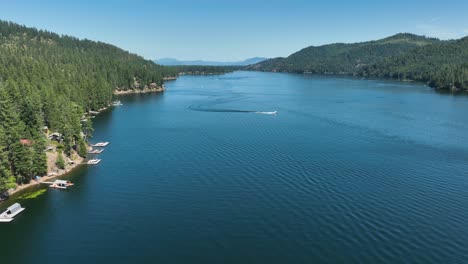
[0,72,468,264]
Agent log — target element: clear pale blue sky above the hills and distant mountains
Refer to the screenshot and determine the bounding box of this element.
[0,0,468,61]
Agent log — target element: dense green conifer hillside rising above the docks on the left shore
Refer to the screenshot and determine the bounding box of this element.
[0,21,172,191]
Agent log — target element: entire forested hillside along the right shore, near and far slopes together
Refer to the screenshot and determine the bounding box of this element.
[247,33,468,91]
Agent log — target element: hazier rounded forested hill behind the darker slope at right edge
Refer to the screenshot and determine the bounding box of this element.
[248,33,440,74]
